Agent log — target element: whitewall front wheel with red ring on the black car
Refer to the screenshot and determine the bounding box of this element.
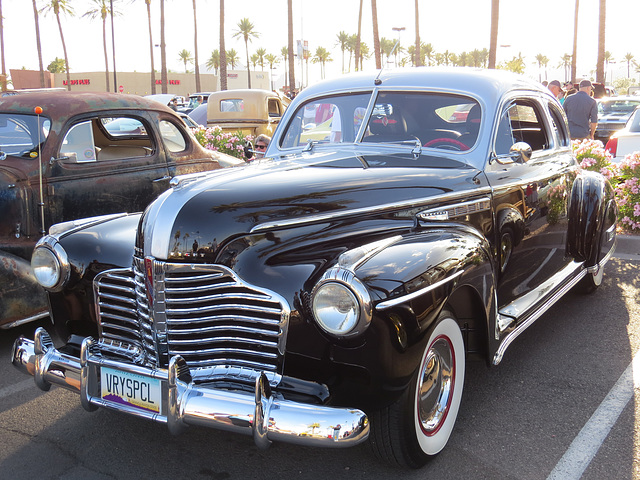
[369,310,465,468]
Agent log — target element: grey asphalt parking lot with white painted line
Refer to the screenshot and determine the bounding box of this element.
[0,236,640,480]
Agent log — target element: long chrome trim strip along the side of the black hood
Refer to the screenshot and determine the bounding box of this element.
[249,187,491,234]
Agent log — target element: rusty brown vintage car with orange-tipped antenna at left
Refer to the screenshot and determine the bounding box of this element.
[0,92,237,328]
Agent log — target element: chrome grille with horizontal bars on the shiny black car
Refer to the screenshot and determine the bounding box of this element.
[95,258,289,381]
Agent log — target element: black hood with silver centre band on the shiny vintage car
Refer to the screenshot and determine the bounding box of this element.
[138,152,478,259]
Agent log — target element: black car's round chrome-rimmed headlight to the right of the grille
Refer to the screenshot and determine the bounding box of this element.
[311,267,372,338]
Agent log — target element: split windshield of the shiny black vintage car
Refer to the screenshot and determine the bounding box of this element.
[281,92,481,151]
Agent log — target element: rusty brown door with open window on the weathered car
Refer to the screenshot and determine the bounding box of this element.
[45,112,170,225]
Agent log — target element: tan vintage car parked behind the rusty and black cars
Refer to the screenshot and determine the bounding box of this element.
[207,89,290,137]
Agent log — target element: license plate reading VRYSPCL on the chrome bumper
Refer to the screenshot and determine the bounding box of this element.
[100,367,162,413]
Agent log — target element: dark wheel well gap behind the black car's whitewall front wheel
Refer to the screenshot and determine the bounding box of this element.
[447,287,487,360]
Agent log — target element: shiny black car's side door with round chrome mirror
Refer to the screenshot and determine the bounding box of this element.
[486,96,575,329]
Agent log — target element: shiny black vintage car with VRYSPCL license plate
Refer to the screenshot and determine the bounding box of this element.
[12,68,616,467]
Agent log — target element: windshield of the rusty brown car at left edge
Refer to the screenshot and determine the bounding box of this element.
[0,113,51,158]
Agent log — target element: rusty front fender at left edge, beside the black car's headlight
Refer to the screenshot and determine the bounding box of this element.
[0,251,49,328]
